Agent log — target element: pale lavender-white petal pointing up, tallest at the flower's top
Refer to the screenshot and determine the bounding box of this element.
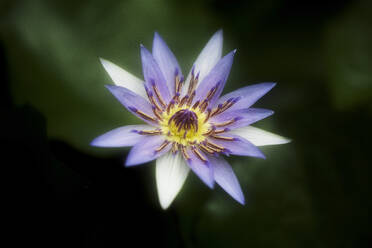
[182,30,223,95]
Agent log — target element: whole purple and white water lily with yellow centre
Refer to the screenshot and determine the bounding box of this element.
[91,30,289,209]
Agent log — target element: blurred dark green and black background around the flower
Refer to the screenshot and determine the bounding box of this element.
[0,0,372,248]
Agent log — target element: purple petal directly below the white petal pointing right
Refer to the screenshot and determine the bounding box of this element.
[211,133,265,158]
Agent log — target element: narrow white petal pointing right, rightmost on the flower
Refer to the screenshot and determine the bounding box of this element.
[230,126,291,146]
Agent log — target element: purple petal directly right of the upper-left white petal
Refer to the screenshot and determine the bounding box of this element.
[141,45,171,103]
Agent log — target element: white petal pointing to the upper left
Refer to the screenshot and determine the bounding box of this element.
[100,58,147,99]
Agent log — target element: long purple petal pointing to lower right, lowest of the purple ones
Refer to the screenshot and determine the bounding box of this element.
[209,156,245,205]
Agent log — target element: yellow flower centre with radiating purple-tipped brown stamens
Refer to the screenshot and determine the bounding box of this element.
[131,70,240,163]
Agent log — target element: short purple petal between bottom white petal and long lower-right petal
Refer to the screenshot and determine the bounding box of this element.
[186,149,214,188]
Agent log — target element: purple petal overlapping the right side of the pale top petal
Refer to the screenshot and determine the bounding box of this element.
[195,50,236,106]
